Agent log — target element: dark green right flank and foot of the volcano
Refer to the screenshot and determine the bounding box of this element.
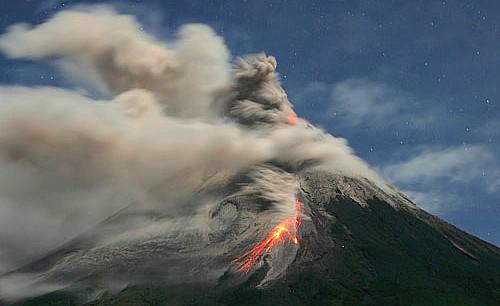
[9,172,500,305]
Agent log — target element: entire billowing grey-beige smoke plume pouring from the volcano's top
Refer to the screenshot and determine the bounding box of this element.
[0,6,384,300]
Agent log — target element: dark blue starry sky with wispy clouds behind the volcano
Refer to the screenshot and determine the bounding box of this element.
[0,0,500,245]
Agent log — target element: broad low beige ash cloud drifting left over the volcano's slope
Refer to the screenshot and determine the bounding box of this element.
[0,87,277,272]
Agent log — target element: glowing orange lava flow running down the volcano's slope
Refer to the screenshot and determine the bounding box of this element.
[231,199,302,273]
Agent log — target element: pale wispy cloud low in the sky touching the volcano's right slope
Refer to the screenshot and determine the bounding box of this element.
[380,145,500,214]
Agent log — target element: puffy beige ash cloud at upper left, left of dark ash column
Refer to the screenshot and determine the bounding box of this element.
[0,6,231,117]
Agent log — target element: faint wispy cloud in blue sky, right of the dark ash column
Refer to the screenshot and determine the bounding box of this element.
[297,78,443,130]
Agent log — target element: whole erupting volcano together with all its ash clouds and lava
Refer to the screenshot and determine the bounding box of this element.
[0,6,500,306]
